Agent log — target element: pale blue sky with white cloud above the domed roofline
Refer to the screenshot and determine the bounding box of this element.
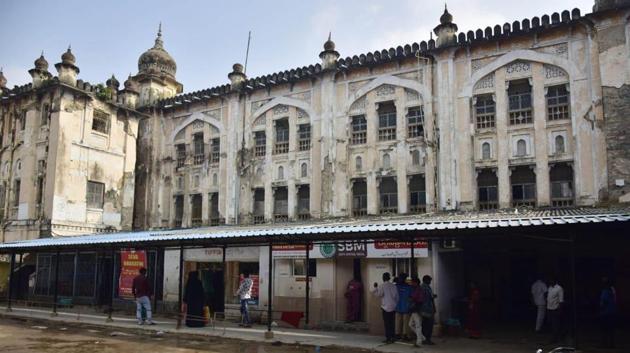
[0,0,593,92]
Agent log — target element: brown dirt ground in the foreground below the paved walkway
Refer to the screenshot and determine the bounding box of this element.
[0,319,365,353]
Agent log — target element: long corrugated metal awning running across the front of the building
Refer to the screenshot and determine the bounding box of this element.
[0,209,630,253]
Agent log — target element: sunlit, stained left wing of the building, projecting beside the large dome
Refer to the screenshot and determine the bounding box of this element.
[0,48,142,242]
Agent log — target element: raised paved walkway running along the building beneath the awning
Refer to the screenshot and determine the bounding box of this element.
[0,307,564,353]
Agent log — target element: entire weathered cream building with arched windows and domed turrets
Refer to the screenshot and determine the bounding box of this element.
[0,0,630,330]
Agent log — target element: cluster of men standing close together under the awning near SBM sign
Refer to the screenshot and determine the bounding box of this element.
[372,272,437,347]
